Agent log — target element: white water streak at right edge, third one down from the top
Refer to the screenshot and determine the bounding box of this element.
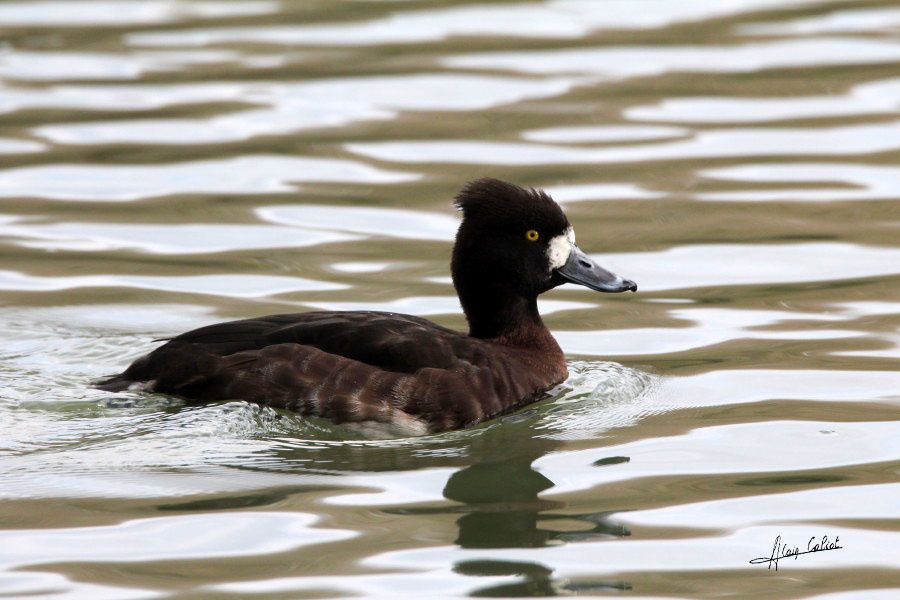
[624,79,900,123]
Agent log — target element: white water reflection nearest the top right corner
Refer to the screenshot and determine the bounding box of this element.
[737,7,900,36]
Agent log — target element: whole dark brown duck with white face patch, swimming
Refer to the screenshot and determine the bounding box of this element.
[95,178,637,435]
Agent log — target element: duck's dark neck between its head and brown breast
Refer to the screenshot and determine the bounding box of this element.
[459,287,559,350]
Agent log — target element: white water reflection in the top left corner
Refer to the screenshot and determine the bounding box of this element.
[0,0,278,27]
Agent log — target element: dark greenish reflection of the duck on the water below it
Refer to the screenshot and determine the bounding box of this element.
[386,422,631,596]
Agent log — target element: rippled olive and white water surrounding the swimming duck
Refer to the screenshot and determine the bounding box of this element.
[0,0,900,599]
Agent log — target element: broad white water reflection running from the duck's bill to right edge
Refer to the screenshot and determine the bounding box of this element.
[584,242,900,292]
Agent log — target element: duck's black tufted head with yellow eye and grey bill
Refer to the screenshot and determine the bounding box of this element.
[451,179,637,338]
